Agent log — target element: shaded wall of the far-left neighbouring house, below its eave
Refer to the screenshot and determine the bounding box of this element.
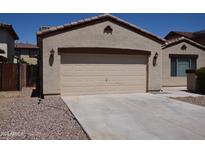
[0,30,14,62]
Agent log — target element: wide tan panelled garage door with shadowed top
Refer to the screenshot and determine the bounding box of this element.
[60,53,147,95]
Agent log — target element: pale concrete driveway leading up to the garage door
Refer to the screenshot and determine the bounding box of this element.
[62,93,205,139]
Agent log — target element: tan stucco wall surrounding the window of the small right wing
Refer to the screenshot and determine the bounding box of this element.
[162,42,205,86]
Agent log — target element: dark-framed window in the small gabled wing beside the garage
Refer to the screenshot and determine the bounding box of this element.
[171,57,196,77]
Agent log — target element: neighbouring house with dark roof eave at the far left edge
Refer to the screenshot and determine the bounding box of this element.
[0,23,19,62]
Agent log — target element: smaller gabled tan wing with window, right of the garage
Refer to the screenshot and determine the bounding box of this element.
[162,36,205,87]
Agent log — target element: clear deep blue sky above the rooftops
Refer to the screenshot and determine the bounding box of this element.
[0,13,205,43]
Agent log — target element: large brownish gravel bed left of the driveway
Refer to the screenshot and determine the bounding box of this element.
[0,92,88,139]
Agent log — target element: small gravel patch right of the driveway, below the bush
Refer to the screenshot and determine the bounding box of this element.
[173,96,205,106]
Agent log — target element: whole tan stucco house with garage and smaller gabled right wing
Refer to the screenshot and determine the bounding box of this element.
[37,14,205,95]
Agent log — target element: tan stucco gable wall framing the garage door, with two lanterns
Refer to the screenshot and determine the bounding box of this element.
[39,21,162,94]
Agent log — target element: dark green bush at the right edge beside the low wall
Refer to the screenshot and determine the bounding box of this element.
[196,67,205,93]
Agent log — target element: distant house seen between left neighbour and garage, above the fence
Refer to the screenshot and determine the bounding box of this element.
[15,43,39,65]
